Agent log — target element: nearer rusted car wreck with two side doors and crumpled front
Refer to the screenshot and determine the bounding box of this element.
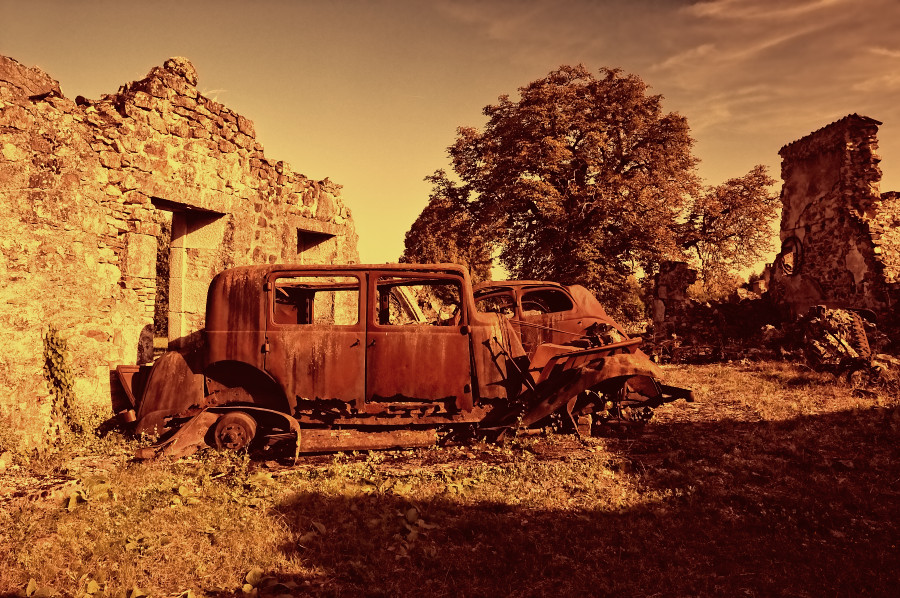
[112,264,690,456]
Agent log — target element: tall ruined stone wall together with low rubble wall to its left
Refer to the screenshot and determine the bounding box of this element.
[653,114,900,358]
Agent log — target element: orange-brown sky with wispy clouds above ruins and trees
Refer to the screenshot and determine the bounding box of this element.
[0,0,900,263]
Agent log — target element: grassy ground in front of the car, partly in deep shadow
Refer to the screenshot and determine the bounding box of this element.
[0,363,900,598]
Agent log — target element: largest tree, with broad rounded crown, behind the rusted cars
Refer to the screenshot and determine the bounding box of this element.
[449,65,698,304]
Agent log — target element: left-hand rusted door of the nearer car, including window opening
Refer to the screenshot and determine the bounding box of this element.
[264,270,366,406]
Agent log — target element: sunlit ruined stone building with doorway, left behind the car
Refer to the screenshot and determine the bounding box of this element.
[0,56,358,450]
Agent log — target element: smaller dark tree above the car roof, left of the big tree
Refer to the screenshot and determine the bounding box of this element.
[400,170,491,282]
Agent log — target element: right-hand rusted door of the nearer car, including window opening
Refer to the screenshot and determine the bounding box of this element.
[366,271,472,411]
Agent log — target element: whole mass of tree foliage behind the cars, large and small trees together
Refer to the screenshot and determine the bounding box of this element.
[404,65,771,299]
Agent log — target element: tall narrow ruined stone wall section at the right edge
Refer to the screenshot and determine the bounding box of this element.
[771,114,900,314]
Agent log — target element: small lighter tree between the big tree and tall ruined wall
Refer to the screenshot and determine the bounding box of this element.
[680,165,780,295]
